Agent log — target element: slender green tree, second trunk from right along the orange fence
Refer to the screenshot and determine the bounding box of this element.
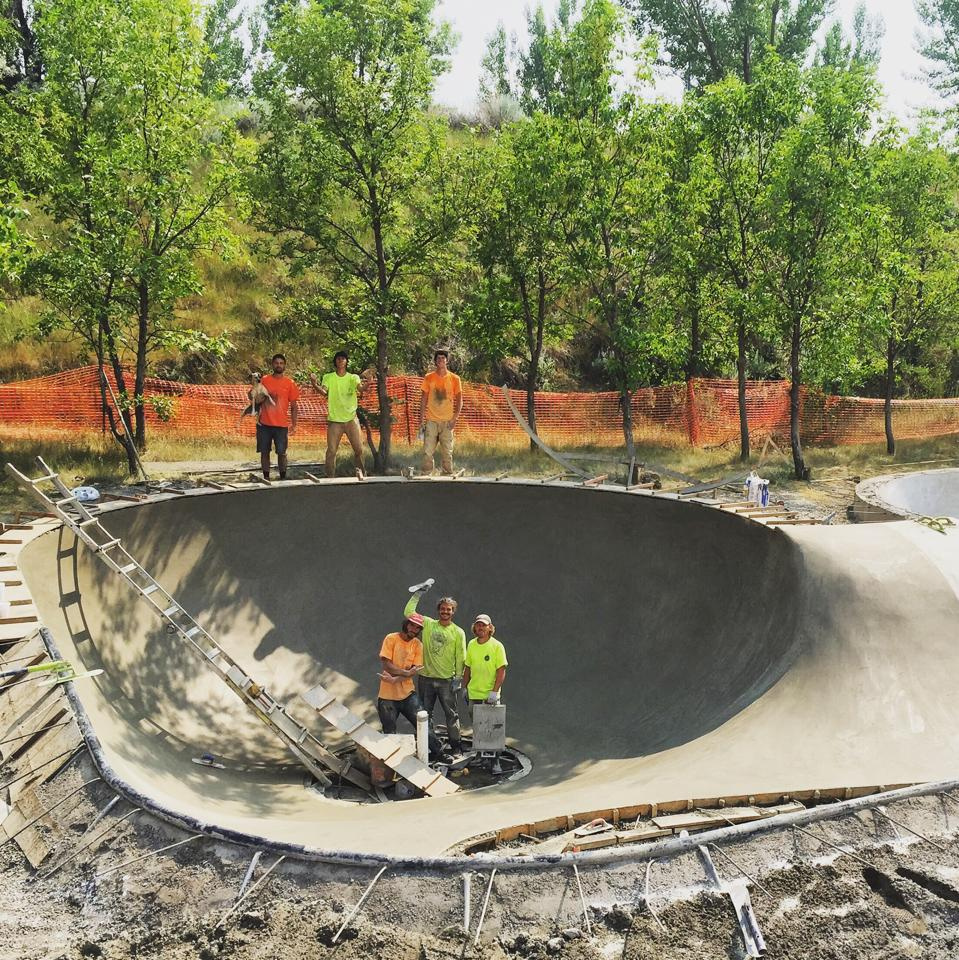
[761,67,877,479]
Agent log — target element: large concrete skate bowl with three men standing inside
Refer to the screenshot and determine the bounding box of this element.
[21,480,959,858]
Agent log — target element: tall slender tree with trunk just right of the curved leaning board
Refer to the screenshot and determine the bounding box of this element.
[553,0,675,458]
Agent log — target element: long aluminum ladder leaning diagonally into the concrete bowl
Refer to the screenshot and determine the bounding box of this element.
[6,457,372,791]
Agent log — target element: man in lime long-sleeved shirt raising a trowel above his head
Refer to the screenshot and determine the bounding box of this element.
[403,580,466,755]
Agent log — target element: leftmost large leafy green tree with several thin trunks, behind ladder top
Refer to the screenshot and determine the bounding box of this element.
[11,0,239,472]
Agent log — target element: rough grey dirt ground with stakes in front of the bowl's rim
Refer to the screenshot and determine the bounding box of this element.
[0,755,959,960]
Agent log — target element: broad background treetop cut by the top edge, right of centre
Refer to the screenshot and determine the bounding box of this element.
[620,0,833,88]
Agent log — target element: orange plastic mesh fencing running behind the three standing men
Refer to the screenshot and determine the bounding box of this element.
[0,366,959,447]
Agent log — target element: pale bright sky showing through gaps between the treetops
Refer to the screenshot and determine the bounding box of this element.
[436,0,936,121]
